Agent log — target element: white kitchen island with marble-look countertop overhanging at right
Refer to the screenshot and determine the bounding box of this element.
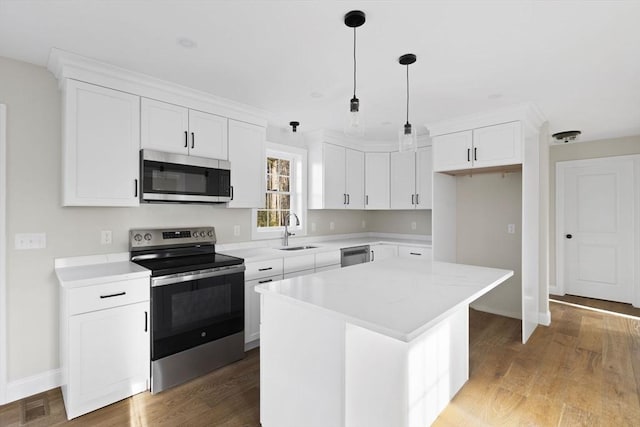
[256,258,513,427]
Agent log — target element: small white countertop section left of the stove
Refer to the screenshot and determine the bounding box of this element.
[56,261,151,288]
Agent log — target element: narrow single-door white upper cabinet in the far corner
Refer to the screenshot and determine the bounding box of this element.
[364,153,390,209]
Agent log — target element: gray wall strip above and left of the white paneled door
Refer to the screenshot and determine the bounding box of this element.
[549,136,640,286]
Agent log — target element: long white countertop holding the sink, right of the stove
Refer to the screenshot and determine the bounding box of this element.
[216,237,431,262]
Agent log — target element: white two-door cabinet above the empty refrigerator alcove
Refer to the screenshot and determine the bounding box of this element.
[433,122,522,172]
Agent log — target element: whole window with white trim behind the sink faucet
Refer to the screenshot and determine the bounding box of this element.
[251,143,307,239]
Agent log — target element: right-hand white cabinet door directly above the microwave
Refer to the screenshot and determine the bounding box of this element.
[189,110,229,160]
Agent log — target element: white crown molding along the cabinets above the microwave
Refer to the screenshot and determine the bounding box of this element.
[47,48,268,127]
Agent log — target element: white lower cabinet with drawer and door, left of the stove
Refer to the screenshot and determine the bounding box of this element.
[60,278,150,419]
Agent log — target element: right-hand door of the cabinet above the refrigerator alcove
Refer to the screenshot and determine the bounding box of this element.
[472,122,522,168]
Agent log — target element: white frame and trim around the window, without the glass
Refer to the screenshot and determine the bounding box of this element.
[251,142,307,240]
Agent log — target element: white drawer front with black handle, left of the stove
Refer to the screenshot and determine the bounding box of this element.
[68,278,151,315]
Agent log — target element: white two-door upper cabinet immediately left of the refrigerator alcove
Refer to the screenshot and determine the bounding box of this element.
[390,147,433,209]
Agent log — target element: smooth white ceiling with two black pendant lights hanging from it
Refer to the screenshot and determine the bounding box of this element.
[0,0,640,141]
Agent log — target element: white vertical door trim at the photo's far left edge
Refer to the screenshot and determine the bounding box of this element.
[0,104,7,405]
